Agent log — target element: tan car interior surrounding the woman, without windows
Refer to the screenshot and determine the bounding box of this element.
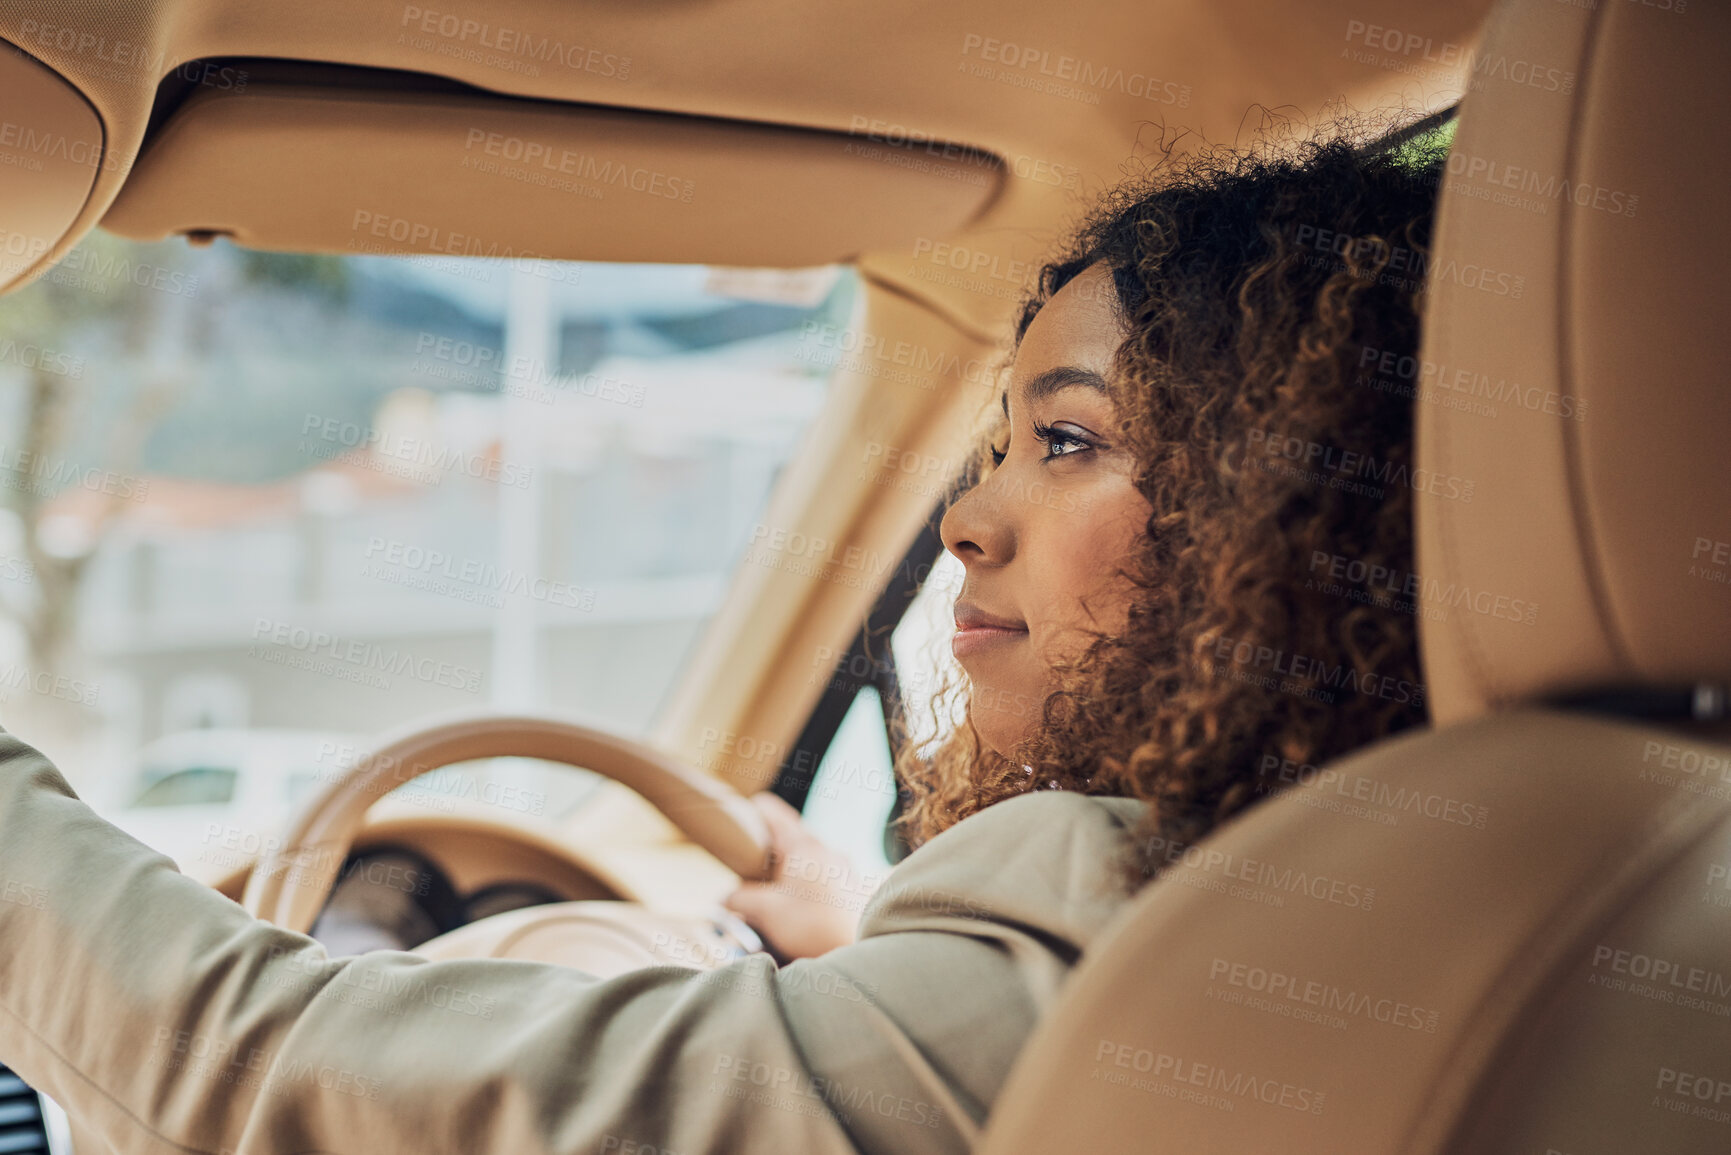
[0,0,1731,1155]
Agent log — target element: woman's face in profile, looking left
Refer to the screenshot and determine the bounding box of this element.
[942,265,1149,757]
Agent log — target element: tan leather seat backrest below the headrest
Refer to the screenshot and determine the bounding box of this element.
[983,712,1731,1155]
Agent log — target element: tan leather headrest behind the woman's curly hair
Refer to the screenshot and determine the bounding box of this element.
[1419,0,1731,724]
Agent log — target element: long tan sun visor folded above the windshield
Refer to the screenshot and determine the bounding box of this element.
[102,83,1002,267]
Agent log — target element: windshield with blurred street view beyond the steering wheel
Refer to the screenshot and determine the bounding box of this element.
[0,234,857,813]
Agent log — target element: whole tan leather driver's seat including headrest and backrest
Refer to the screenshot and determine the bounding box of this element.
[981,0,1731,1155]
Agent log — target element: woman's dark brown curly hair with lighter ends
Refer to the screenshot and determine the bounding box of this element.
[898,115,1447,880]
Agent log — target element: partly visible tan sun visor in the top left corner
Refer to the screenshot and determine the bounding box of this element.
[0,42,102,289]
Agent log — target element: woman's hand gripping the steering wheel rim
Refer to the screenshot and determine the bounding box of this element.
[727,793,883,961]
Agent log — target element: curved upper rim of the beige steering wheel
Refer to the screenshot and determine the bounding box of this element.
[242,715,769,933]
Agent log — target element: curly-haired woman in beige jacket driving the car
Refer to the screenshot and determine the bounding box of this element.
[0,119,1440,1155]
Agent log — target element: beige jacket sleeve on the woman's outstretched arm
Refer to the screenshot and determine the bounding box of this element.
[0,734,1127,1155]
